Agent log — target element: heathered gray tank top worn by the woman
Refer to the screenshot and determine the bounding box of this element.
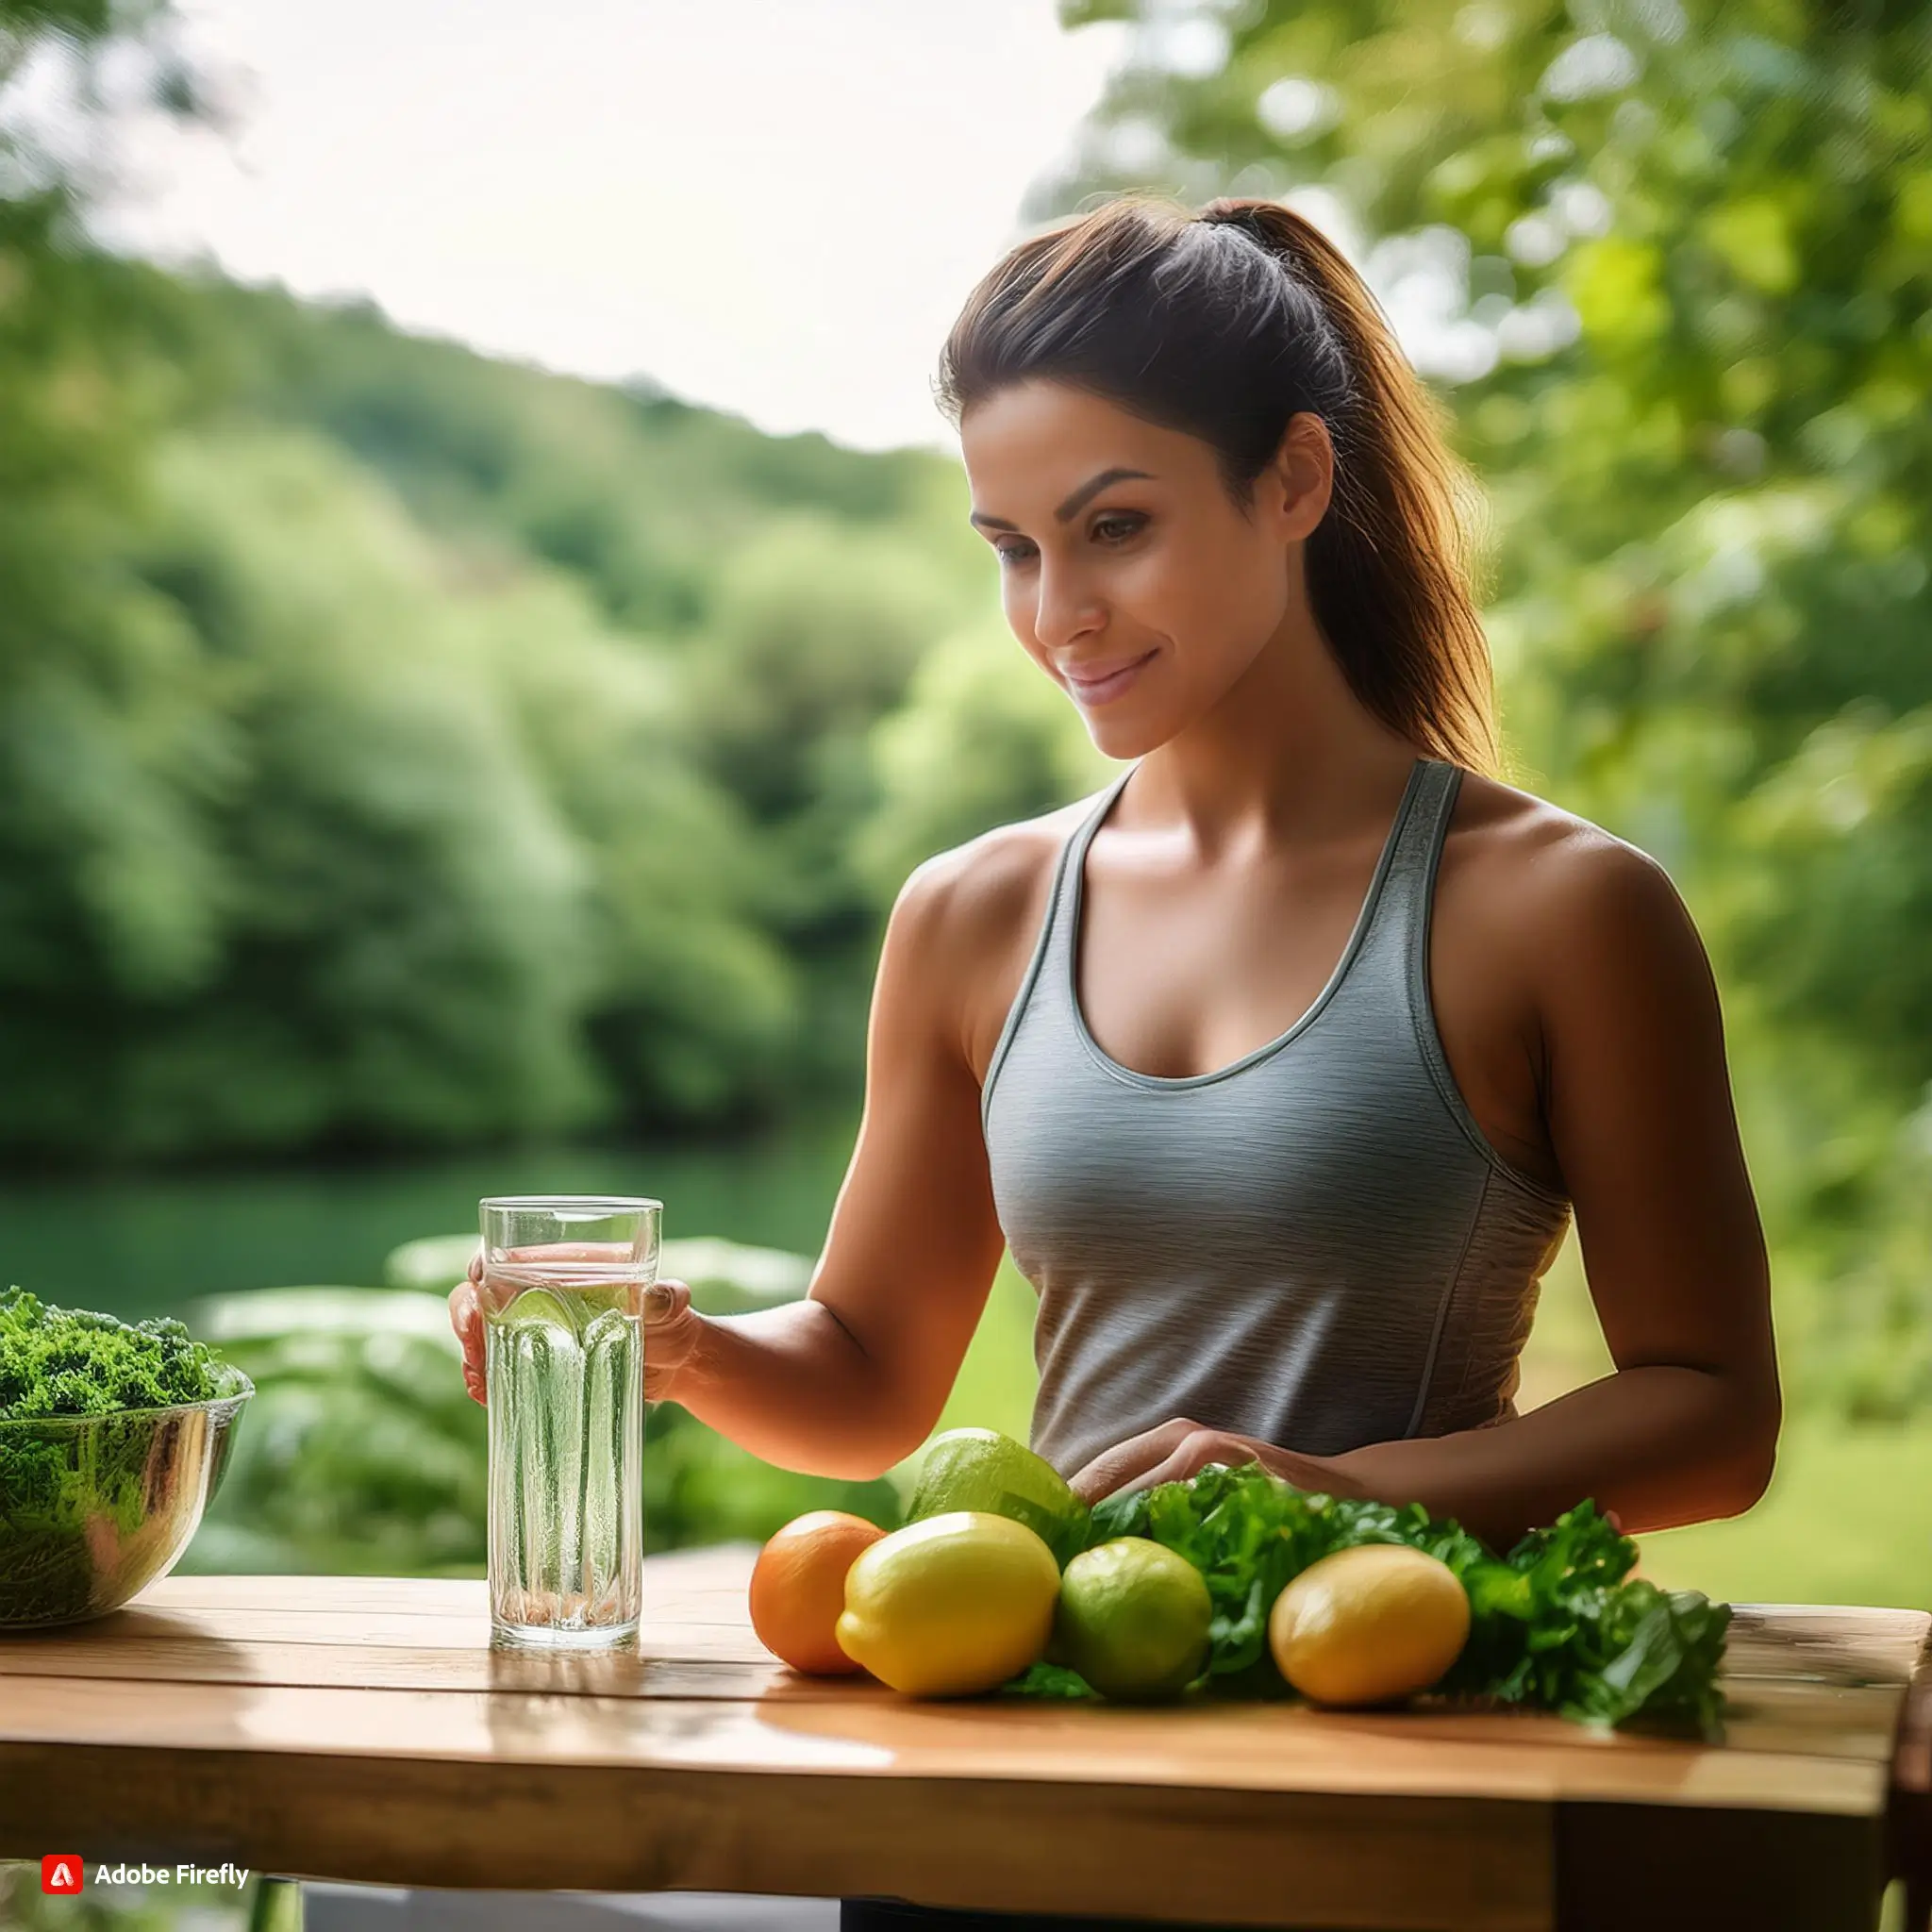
[979,758,1571,1476]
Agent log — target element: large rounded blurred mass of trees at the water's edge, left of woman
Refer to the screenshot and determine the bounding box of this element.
[0,429,792,1156]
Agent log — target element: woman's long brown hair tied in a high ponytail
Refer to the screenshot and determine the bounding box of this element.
[935,193,1499,776]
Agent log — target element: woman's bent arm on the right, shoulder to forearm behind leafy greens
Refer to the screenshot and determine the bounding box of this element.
[1325,831,1783,1549]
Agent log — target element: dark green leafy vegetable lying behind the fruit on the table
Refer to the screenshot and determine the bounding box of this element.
[1005,1462,1731,1737]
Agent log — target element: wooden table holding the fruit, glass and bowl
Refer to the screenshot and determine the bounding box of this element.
[0,1545,1932,1932]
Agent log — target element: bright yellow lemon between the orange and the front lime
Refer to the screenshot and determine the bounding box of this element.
[837,1508,1060,1696]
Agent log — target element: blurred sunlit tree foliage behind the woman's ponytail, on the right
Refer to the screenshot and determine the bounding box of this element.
[1028,0,1932,1414]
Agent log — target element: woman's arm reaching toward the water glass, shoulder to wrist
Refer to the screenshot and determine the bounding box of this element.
[665,848,1005,1478]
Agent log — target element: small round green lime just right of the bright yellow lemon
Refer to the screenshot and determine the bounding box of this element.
[1053,1536,1213,1698]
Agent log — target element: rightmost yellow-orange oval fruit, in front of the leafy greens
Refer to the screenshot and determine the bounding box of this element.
[1267,1543,1468,1704]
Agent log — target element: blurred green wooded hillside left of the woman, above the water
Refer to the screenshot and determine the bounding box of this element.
[0,0,989,1159]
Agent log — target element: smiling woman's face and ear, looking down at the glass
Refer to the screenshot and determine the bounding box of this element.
[960,380,1329,758]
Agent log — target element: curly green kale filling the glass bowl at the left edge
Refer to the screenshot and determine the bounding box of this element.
[0,1289,220,1422]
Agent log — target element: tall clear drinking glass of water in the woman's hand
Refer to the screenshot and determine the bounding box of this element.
[479,1194,665,1650]
